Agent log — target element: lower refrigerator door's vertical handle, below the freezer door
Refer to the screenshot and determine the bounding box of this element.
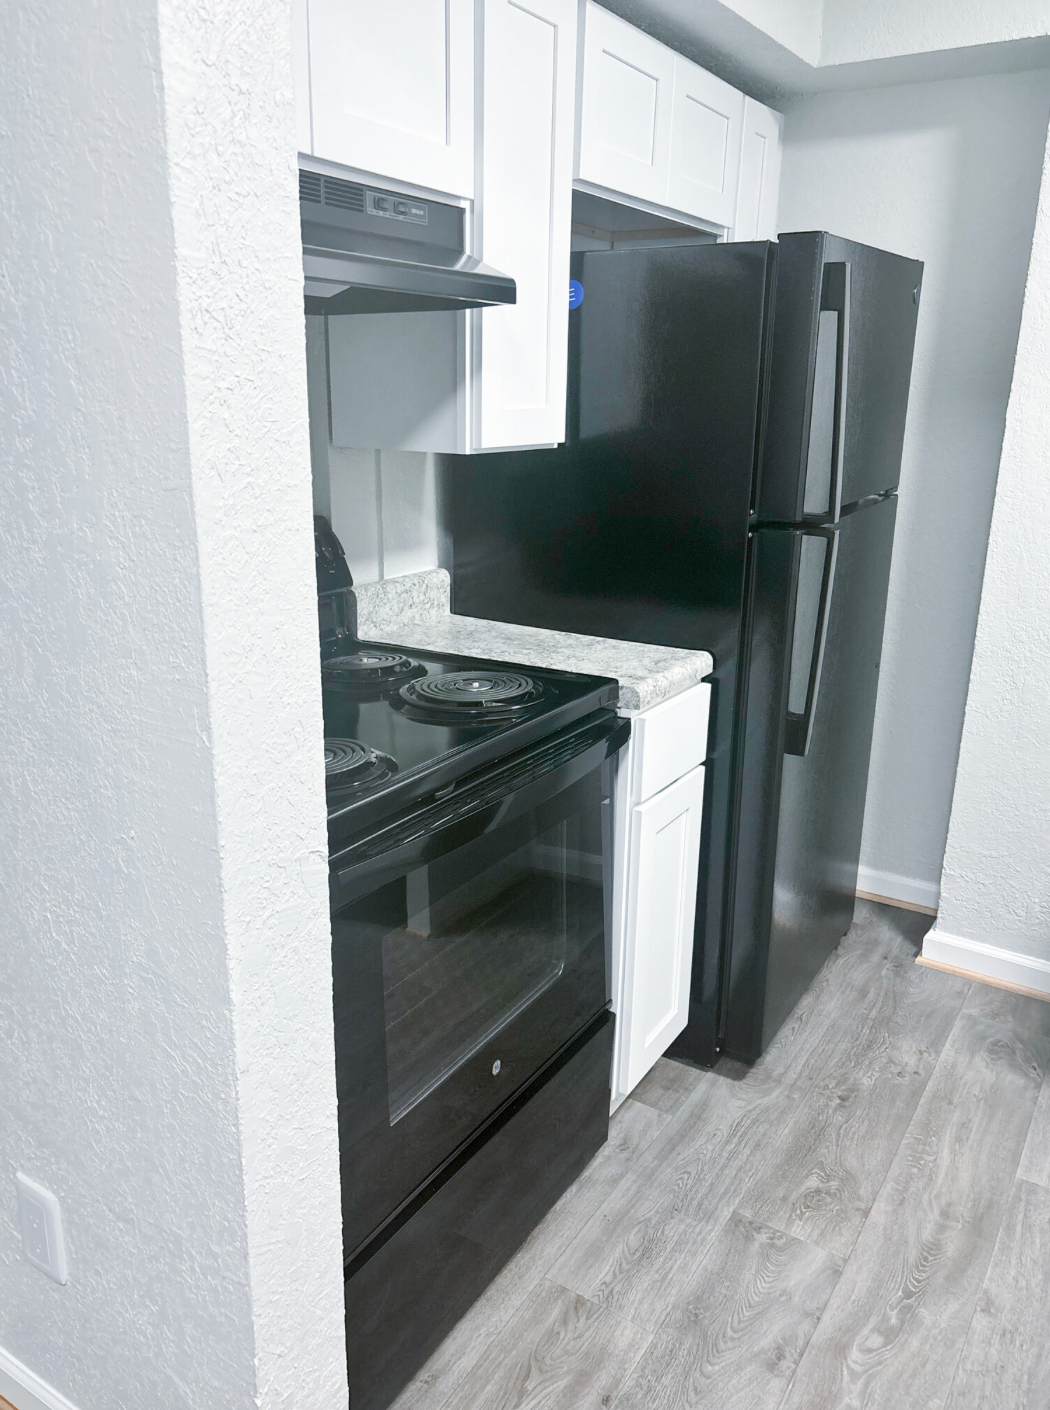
[784,529,839,757]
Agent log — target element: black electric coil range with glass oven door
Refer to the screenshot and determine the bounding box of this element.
[321,635,630,1410]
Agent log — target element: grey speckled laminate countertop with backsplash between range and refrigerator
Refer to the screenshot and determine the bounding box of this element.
[355,568,715,711]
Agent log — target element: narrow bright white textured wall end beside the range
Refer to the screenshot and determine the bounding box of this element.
[159,0,347,1410]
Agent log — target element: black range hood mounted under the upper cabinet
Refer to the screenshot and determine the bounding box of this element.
[299,169,516,313]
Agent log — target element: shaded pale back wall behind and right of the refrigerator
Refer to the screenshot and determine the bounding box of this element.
[781,72,1050,905]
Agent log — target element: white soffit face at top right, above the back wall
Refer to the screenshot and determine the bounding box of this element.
[820,0,1050,65]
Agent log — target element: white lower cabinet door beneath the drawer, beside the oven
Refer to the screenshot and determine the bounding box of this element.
[617,766,703,1094]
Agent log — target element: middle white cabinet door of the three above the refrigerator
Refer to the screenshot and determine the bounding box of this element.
[667,55,744,228]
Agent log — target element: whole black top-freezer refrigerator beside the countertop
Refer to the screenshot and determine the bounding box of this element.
[451,233,922,1065]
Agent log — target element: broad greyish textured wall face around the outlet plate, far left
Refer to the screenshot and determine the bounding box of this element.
[0,0,255,1410]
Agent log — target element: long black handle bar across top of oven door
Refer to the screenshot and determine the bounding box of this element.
[330,711,630,907]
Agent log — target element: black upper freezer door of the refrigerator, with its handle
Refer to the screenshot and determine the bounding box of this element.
[757,233,922,523]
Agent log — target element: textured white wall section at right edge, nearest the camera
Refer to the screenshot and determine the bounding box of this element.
[932,121,1050,990]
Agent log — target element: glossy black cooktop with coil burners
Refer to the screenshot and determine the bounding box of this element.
[321,642,619,836]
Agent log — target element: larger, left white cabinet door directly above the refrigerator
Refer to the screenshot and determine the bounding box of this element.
[576,3,675,204]
